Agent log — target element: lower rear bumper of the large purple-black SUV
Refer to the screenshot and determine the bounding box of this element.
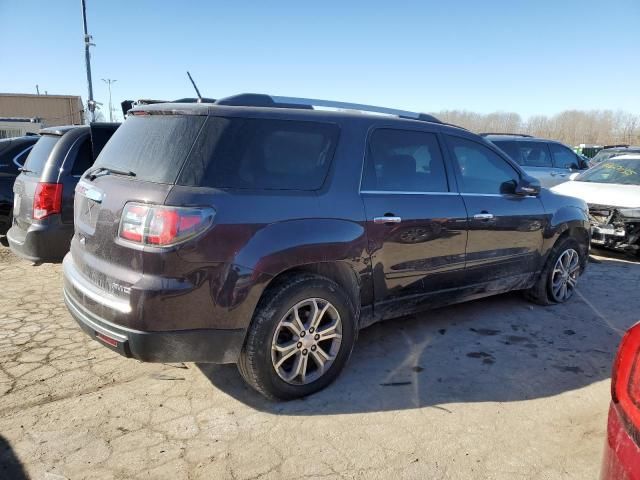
[63,257,246,363]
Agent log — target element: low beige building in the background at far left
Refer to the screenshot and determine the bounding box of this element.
[0,93,84,127]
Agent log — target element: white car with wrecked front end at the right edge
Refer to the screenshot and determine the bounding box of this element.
[551,155,640,256]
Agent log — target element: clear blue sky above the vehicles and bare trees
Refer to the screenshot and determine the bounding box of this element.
[0,0,640,117]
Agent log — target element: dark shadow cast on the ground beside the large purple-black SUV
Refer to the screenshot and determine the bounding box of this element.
[198,253,640,415]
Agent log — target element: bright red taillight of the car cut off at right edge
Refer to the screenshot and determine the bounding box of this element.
[611,323,640,438]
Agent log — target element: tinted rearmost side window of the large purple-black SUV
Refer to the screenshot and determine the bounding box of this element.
[178,117,338,190]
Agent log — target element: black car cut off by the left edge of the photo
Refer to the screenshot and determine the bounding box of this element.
[0,135,39,235]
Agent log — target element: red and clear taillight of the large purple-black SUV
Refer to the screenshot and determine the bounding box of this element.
[120,203,215,246]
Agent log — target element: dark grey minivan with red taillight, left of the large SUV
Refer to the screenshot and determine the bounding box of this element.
[7,123,119,262]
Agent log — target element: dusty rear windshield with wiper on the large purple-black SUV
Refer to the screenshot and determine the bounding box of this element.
[94,115,206,183]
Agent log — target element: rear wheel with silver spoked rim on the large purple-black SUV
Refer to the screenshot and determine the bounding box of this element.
[238,274,356,400]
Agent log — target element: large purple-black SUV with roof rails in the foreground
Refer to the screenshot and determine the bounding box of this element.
[63,95,589,399]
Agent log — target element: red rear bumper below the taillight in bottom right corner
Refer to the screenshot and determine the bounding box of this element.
[600,404,640,480]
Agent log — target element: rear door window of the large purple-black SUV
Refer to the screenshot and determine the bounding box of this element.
[362,129,449,193]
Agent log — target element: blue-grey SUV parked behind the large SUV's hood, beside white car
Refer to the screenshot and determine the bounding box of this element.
[482,133,589,188]
